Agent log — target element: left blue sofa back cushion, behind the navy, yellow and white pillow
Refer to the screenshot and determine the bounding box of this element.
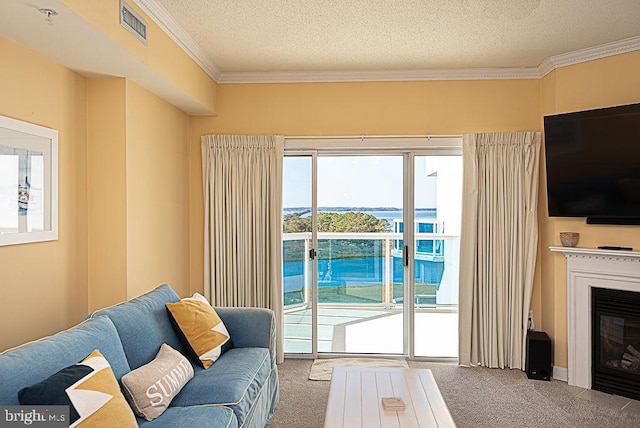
[0,317,130,405]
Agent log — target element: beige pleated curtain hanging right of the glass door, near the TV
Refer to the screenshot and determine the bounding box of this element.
[459,132,540,369]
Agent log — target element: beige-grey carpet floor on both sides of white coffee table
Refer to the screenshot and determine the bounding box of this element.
[267,359,640,428]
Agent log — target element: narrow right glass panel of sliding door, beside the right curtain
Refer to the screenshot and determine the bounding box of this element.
[413,156,462,358]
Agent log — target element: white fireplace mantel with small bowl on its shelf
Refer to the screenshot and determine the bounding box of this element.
[549,247,640,389]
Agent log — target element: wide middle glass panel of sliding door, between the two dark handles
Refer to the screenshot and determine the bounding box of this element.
[316,155,404,354]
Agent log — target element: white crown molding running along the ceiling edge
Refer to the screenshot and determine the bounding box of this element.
[132,0,640,84]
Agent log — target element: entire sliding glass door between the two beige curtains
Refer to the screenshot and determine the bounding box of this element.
[283,140,461,357]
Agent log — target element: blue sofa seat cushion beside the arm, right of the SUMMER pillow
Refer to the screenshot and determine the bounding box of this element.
[171,348,271,426]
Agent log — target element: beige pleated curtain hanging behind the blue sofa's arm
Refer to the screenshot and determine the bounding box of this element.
[202,135,284,362]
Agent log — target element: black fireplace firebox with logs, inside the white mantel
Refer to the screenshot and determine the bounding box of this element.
[591,288,640,400]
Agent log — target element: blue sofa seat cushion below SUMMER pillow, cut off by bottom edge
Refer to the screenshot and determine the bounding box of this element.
[138,406,238,428]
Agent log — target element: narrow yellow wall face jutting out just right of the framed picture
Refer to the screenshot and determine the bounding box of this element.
[87,79,127,311]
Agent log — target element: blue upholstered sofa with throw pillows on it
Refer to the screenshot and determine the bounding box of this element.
[0,284,279,428]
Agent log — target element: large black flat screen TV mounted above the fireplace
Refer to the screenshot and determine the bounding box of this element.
[544,104,640,224]
